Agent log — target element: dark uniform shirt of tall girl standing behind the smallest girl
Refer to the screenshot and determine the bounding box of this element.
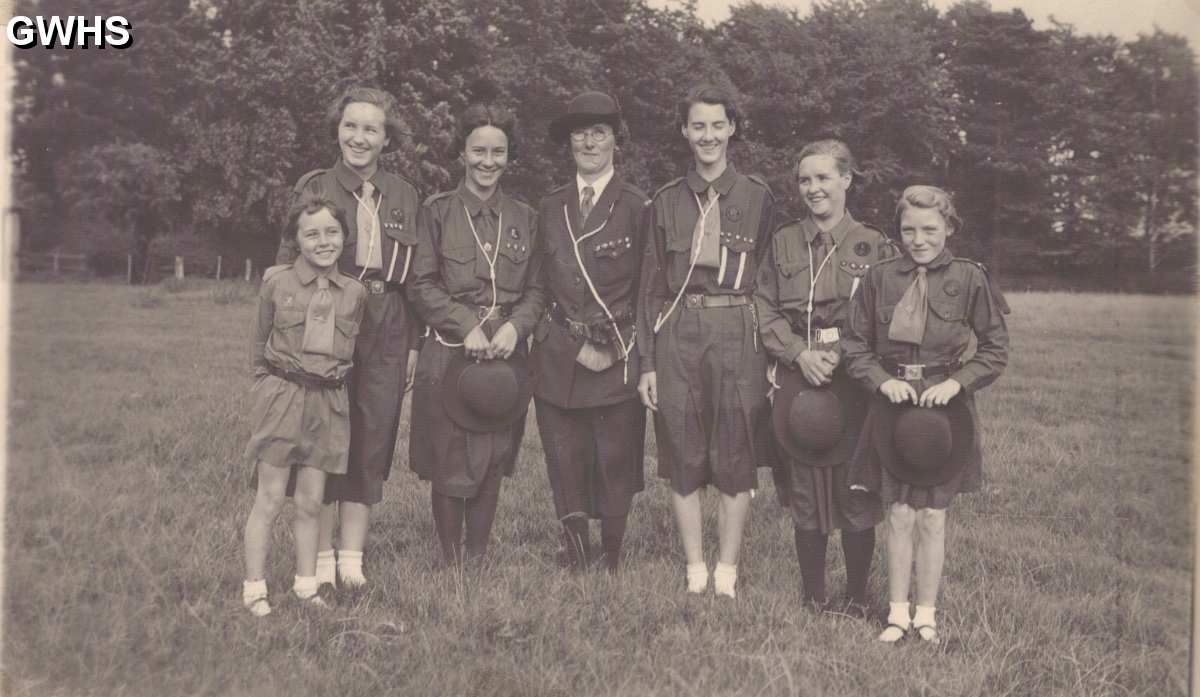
[275,158,421,283]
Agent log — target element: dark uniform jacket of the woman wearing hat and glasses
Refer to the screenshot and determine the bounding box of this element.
[530,174,649,408]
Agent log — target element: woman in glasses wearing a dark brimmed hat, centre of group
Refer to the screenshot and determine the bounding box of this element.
[530,92,646,573]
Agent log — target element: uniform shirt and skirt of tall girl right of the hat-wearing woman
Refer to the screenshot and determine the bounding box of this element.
[637,164,775,495]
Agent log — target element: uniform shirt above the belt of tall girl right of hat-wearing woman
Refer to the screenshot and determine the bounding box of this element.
[637,164,775,373]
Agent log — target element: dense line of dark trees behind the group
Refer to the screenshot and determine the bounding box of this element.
[12,0,1198,290]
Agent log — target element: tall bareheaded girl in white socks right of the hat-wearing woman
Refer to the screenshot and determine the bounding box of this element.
[637,85,775,597]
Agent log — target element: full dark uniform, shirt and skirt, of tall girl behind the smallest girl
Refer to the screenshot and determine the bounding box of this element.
[276,160,422,504]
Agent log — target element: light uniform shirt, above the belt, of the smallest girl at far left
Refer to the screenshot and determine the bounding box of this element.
[251,252,366,378]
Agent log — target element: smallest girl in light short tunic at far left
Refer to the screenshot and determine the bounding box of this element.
[241,198,366,617]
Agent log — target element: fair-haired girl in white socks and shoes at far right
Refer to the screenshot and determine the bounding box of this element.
[842,186,1008,642]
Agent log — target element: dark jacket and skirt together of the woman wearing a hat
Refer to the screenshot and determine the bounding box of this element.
[529,175,648,518]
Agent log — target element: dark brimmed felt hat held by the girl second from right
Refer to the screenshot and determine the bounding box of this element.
[770,366,850,467]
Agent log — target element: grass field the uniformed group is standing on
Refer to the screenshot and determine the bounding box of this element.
[0,279,1196,697]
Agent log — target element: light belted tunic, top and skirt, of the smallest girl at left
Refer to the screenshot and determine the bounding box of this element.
[245,257,366,472]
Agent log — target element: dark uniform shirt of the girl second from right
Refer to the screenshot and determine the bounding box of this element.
[755,212,895,365]
